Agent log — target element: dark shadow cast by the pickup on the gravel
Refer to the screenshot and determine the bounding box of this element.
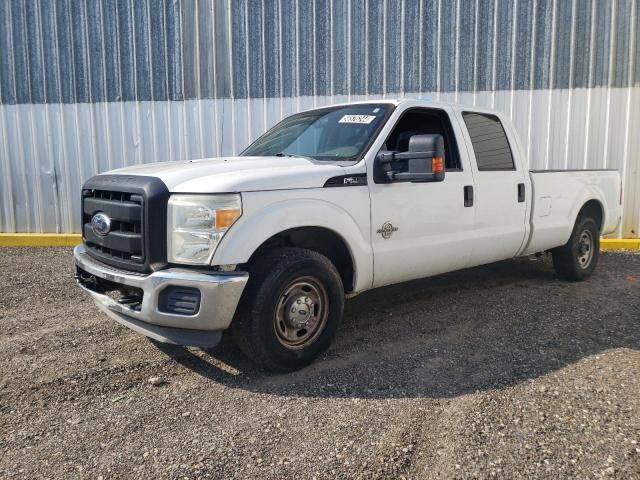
[152,255,640,398]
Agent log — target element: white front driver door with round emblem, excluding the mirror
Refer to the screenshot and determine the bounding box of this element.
[368,107,475,287]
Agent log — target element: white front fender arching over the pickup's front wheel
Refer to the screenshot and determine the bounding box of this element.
[212,187,373,292]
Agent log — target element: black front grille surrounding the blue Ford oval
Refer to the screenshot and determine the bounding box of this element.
[82,175,169,272]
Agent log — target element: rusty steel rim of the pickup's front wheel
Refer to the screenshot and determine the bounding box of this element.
[273,277,329,349]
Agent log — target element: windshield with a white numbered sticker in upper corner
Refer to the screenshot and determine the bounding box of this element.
[242,104,391,161]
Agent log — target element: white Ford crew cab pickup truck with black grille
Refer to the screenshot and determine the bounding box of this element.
[74,100,621,371]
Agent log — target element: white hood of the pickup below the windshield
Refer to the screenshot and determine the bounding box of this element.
[109,157,352,193]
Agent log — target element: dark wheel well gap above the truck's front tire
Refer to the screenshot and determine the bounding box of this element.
[249,227,354,293]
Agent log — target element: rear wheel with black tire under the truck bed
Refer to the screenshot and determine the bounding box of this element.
[551,217,600,282]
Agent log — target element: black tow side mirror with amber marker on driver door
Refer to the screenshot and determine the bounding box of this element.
[376,135,444,183]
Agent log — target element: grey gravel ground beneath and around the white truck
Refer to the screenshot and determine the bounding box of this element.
[0,248,640,479]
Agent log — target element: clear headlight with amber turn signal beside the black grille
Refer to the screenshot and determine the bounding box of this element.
[167,194,242,265]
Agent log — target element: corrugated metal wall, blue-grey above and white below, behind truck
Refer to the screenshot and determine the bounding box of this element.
[0,0,640,237]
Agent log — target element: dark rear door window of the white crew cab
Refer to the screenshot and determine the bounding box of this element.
[462,112,516,172]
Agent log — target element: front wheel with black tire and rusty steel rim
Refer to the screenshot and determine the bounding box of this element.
[231,248,344,372]
